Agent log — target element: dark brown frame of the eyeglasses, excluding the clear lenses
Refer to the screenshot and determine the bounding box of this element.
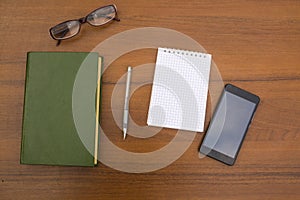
[49,4,121,46]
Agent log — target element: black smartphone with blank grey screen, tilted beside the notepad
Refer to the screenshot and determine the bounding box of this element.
[200,84,260,165]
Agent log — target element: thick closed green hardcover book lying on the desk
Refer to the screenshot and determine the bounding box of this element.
[20,52,102,166]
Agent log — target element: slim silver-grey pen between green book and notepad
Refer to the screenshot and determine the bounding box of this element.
[123,66,131,140]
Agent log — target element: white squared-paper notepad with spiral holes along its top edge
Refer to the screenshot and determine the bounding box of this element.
[147,48,211,132]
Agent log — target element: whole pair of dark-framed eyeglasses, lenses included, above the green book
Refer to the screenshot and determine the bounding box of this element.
[49,5,120,46]
